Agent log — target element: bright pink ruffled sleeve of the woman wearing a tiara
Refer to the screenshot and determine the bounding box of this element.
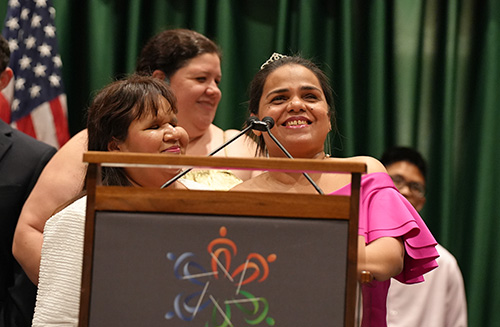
[333,173,439,284]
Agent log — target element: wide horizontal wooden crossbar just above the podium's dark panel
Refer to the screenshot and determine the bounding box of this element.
[89,186,351,219]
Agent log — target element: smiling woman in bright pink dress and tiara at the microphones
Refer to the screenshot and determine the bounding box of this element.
[233,54,438,326]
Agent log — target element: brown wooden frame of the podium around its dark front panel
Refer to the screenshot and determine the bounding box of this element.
[79,152,366,327]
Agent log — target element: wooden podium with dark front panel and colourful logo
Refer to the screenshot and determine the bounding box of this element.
[79,152,366,327]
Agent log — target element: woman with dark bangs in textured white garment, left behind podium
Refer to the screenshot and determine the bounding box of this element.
[33,75,205,326]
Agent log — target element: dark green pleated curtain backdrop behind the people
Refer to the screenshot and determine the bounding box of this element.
[0,0,500,326]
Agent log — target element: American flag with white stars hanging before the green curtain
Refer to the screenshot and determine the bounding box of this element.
[0,0,69,148]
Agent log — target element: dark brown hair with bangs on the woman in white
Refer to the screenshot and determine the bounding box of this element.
[87,75,177,186]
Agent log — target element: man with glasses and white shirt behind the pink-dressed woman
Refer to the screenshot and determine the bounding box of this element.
[381,147,467,327]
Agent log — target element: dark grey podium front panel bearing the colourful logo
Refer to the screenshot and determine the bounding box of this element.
[89,211,349,326]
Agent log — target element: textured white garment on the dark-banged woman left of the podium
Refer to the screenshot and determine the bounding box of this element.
[33,179,210,326]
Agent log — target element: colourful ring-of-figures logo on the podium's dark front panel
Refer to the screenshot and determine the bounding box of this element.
[165,226,277,327]
